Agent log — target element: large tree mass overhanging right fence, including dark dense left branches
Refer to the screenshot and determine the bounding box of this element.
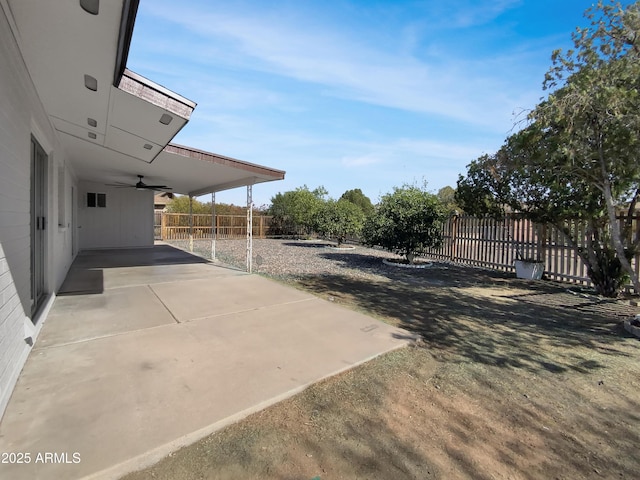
[456,2,640,296]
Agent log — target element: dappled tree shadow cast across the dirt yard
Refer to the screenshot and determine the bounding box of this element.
[297,267,633,372]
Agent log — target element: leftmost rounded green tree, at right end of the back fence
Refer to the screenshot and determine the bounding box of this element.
[269,185,327,235]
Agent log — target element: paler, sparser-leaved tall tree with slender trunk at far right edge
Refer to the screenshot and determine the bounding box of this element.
[530,0,640,292]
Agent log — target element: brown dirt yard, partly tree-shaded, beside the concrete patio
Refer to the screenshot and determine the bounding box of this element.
[125,244,640,480]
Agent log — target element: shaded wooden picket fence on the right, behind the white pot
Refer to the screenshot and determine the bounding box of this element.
[428,215,640,290]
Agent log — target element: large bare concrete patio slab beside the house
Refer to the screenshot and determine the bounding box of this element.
[0,245,409,480]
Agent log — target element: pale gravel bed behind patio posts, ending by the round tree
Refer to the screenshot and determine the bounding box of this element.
[167,239,416,280]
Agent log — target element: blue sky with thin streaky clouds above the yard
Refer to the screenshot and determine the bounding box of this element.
[128,0,612,205]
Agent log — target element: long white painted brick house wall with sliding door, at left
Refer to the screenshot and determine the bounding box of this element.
[0,5,74,417]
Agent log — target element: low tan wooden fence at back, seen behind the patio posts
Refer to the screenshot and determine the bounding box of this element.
[156,212,271,240]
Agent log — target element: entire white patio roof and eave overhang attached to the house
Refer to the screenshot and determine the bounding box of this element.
[5,0,285,195]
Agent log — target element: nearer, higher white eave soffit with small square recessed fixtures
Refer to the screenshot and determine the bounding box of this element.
[8,0,195,167]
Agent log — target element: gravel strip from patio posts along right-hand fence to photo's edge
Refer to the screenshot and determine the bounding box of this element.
[166,239,638,308]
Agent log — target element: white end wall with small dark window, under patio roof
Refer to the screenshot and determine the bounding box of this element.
[78,181,153,250]
